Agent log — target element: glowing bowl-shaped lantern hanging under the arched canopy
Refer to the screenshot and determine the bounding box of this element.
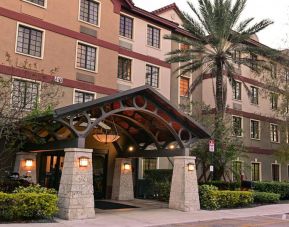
[93,119,120,143]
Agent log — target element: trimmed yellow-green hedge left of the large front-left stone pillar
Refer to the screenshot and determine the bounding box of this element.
[0,192,58,220]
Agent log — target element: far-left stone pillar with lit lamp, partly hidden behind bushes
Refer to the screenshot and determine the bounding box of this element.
[14,152,37,183]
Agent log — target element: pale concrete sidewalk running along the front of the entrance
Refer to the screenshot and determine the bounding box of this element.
[0,204,289,227]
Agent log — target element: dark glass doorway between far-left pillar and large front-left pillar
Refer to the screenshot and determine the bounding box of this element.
[39,152,64,190]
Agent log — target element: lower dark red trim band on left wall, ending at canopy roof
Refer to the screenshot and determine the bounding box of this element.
[0,64,118,95]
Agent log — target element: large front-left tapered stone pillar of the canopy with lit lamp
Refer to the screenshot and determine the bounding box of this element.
[58,148,95,220]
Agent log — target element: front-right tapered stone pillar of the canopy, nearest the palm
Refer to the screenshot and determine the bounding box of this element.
[169,156,200,212]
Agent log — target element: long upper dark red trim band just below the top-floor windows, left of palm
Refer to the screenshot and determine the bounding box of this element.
[0,7,171,68]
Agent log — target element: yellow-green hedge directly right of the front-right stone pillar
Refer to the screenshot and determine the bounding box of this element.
[199,185,253,210]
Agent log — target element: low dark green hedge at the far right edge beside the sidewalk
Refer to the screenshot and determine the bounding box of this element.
[253,182,289,200]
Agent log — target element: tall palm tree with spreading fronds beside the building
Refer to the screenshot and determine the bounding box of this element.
[165,0,280,181]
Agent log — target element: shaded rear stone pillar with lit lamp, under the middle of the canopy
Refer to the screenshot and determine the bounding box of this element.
[111,158,134,200]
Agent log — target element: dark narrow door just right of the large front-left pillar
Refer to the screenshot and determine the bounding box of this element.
[92,154,107,199]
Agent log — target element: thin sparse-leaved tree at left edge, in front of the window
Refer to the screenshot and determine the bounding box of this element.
[0,53,63,174]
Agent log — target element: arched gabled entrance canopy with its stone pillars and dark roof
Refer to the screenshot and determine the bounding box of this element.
[16,86,209,219]
